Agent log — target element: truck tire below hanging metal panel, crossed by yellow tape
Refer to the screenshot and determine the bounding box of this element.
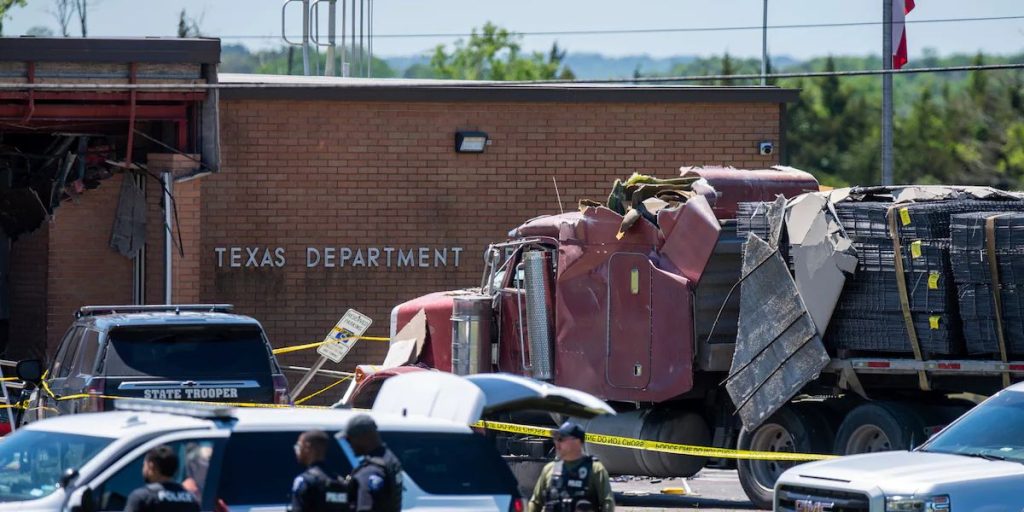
[736,404,833,510]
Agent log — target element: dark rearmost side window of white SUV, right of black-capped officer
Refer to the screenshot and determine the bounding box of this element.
[381,432,518,496]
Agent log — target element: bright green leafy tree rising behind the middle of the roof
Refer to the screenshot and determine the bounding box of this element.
[430,22,572,80]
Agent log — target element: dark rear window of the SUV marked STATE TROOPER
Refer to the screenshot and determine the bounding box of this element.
[103,325,271,378]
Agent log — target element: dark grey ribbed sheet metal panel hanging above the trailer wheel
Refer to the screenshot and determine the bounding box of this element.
[725,234,829,429]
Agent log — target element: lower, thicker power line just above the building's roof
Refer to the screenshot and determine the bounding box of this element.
[512,62,1024,84]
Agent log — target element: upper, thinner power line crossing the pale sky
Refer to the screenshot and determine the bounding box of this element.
[215,15,1024,39]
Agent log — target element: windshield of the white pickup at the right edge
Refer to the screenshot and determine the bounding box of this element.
[921,391,1024,463]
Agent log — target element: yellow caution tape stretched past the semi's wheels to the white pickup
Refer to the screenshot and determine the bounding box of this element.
[472,421,836,462]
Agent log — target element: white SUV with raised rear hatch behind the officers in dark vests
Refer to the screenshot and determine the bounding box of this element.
[0,373,611,512]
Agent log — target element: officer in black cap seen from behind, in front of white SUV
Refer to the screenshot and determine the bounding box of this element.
[339,415,401,512]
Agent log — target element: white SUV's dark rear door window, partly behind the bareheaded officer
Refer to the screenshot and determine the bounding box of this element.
[217,430,352,508]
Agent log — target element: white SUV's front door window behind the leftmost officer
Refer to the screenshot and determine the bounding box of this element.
[93,439,214,511]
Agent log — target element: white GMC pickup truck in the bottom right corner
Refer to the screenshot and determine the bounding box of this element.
[774,383,1024,512]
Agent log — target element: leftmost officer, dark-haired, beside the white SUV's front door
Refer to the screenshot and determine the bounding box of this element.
[125,444,200,512]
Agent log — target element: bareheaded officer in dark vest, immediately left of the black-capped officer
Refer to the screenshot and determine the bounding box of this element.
[290,430,351,512]
